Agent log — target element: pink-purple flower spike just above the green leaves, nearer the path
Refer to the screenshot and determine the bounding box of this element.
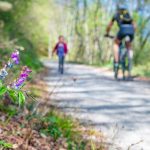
[12,66,32,89]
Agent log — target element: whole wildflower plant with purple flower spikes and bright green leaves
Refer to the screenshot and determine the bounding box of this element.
[0,50,32,106]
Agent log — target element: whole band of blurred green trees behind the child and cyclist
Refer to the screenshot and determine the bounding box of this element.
[0,0,150,74]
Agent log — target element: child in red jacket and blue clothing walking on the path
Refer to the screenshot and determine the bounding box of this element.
[52,35,68,74]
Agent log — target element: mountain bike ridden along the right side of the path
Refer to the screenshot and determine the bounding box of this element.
[105,35,133,80]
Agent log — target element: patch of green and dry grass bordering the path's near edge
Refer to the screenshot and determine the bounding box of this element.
[27,109,105,150]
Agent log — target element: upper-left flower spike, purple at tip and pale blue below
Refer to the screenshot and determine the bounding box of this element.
[0,50,19,80]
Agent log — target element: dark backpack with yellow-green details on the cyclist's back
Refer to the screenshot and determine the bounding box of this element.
[119,9,132,24]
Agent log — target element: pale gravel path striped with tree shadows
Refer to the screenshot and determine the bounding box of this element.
[45,61,150,150]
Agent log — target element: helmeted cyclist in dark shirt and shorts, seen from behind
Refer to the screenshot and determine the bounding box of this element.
[106,5,135,77]
